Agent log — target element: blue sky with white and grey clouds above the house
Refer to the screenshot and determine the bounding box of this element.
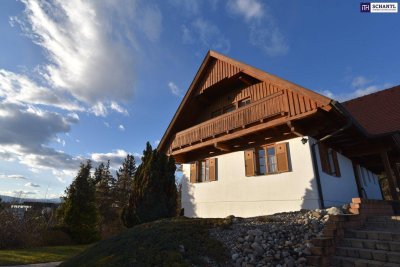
[0,0,400,201]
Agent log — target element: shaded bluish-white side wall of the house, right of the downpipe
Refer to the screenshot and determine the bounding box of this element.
[310,138,364,207]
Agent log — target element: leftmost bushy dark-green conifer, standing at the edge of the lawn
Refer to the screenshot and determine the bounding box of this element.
[62,161,99,243]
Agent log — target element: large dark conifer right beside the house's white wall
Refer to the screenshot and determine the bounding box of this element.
[122,142,177,227]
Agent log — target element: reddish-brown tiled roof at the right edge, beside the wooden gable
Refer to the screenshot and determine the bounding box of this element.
[343,85,400,135]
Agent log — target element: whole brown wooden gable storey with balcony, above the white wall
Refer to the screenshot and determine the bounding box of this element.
[160,51,331,162]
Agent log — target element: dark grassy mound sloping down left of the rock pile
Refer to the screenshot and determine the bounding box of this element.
[60,218,230,267]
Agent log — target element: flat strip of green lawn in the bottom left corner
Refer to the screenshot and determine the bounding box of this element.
[0,245,89,265]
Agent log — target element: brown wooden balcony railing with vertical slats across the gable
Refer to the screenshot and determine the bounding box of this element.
[170,91,289,151]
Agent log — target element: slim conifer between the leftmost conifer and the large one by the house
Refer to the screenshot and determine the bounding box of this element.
[115,154,136,209]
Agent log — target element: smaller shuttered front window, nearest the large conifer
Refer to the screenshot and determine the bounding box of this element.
[190,158,217,183]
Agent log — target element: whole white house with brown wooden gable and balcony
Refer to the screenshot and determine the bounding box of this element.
[158,51,400,217]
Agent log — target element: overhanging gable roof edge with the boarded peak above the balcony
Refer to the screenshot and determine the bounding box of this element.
[158,50,332,153]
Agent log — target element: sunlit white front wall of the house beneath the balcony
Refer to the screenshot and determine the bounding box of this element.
[182,138,318,217]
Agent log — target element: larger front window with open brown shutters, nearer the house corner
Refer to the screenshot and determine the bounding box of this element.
[245,143,289,176]
